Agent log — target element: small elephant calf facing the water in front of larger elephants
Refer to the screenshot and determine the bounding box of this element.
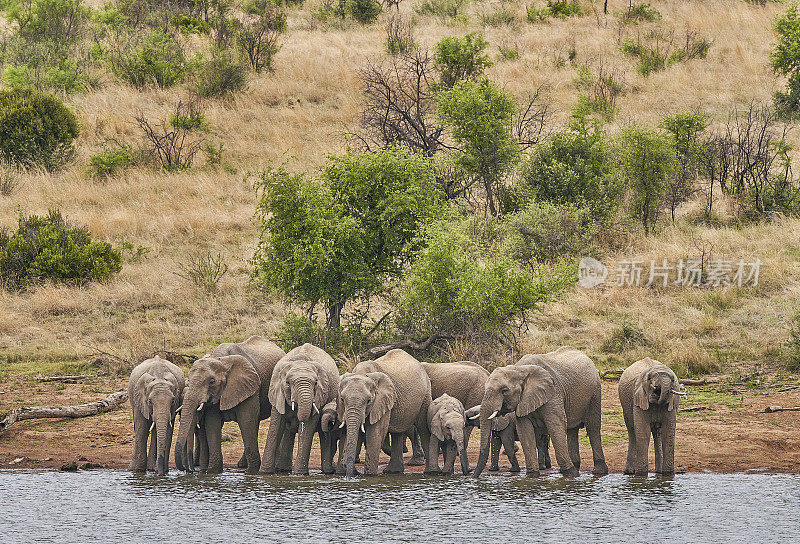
[428,393,469,476]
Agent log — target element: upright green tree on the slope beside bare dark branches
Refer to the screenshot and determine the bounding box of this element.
[437,78,520,215]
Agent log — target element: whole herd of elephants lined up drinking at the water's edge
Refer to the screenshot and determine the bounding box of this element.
[128,336,684,477]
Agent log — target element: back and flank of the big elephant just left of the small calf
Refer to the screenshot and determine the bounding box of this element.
[353,349,431,432]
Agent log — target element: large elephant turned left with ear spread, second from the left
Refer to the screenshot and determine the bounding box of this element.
[175,336,286,474]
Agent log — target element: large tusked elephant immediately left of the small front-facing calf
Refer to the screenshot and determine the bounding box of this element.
[338,349,433,477]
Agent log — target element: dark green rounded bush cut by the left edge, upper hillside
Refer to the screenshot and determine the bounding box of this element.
[0,89,78,171]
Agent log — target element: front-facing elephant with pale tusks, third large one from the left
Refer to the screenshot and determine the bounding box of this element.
[261,344,339,474]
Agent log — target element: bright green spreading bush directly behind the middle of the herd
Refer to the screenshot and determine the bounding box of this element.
[396,222,574,344]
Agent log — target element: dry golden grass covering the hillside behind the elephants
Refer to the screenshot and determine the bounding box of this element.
[0,0,800,370]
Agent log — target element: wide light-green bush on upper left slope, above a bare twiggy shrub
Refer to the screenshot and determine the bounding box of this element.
[108,30,187,89]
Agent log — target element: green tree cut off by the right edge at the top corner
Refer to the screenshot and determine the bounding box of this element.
[770,2,800,116]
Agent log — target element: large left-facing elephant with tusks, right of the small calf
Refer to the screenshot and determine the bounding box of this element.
[474,346,608,477]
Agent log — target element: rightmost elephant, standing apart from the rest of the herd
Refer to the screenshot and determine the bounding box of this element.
[618,357,685,476]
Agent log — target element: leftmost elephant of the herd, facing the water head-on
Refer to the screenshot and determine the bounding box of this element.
[128,356,186,476]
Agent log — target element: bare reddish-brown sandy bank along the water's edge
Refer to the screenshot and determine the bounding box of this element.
[0,375,800,473]
